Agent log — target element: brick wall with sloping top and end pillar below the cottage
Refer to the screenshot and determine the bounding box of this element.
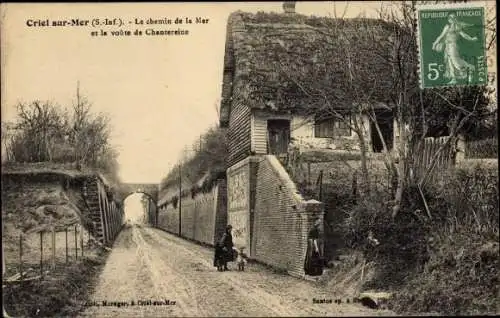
[250,155,323,277]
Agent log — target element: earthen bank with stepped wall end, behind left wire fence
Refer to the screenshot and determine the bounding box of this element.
[2,172,124,244]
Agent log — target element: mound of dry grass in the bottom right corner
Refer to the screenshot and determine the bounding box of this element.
[391,228,499,315]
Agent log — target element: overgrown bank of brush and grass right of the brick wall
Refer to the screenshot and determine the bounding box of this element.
[327,162,500,315]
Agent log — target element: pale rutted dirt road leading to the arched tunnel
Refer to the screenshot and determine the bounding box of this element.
[81,225,392,317]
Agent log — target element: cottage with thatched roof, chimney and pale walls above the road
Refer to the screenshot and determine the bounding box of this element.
[220,3,395,166]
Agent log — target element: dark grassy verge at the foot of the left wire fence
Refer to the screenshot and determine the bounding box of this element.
[3,249,108,317]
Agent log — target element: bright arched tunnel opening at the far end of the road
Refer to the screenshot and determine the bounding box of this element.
[123,192,156,225]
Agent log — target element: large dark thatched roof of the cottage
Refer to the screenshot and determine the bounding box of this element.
[220,11,392,126]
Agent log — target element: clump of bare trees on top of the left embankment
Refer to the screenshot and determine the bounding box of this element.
[2,85,118,181]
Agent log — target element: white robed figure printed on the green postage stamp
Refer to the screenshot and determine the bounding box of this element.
[432,13,477,84]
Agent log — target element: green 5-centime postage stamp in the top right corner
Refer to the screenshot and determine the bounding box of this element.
[417,3,488,88]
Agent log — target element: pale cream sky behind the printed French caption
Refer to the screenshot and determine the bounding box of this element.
[1,1,496,183]
